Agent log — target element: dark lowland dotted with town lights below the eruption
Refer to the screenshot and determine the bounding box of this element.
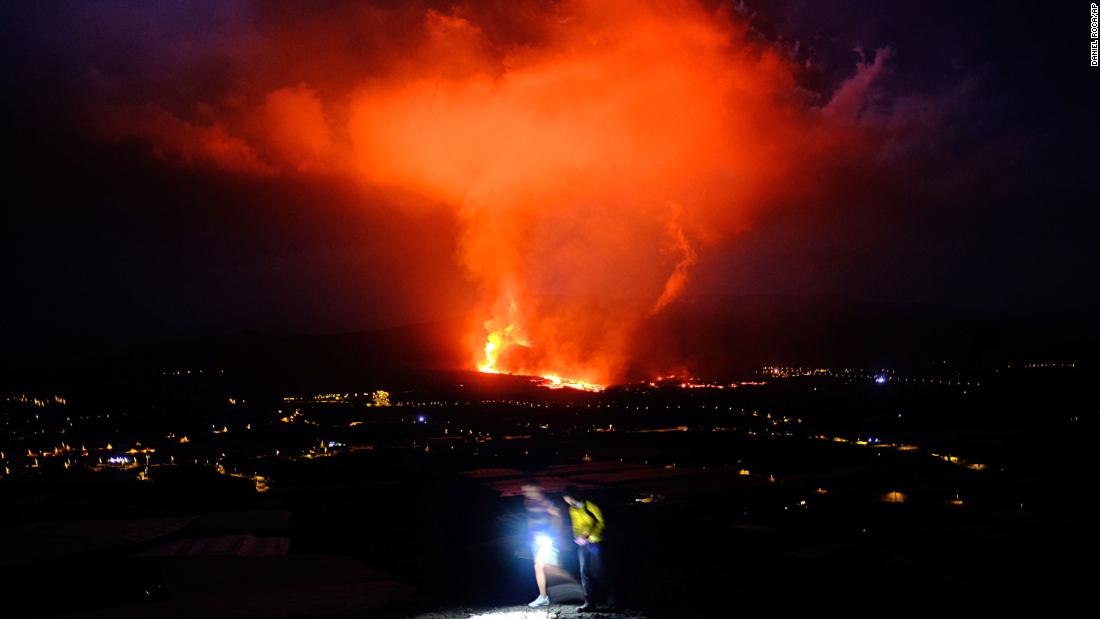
[0,329,1098,617]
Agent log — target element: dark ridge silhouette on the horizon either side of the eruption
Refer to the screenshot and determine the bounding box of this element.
[3,296,1100,387]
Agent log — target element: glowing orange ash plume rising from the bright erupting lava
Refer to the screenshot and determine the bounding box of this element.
[92,0,881,388]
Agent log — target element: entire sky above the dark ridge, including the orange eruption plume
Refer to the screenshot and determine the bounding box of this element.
[6,0,1091,376]
